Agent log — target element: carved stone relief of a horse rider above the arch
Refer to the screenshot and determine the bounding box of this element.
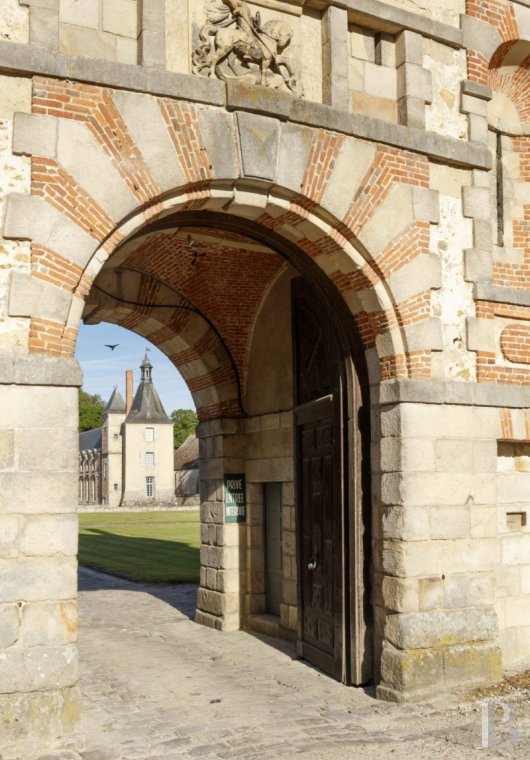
[192,0,297,92]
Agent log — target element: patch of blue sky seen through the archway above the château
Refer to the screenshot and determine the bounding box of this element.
[76,322,195,414]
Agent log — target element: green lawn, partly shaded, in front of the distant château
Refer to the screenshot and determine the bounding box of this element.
[79,512,200,583]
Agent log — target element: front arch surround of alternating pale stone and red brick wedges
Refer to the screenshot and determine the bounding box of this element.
[5,78,439,377]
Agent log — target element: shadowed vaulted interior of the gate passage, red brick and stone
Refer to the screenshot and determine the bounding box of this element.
[83,217,366,683]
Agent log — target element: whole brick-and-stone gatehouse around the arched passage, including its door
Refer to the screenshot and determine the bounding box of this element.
[0,0,530,740]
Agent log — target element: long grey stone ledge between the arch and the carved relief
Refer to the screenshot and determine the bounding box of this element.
[0,41,491,169]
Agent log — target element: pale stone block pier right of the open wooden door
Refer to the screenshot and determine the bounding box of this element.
[373,403,501,699]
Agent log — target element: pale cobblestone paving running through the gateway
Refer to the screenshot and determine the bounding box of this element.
[6,570,530,760]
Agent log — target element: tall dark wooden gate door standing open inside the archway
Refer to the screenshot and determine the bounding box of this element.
[292,280,348,681]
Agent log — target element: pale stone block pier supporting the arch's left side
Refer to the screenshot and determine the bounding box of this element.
[0,374,80,743]
